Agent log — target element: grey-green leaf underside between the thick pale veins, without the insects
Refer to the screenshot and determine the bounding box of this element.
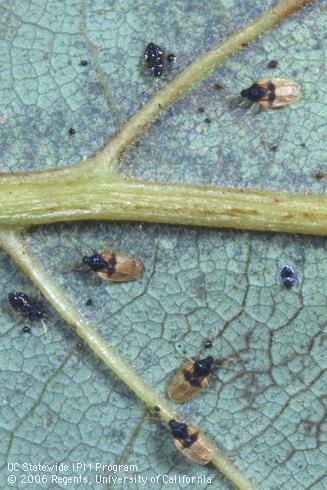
[0,0,327,490]
